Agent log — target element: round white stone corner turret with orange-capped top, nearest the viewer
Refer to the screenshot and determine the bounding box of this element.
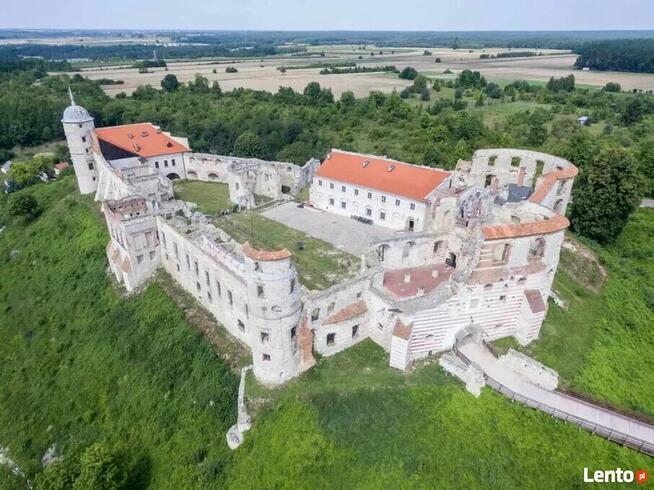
[241,243,302,384]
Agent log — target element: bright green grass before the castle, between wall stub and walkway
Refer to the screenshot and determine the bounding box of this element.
[226,341,652,489]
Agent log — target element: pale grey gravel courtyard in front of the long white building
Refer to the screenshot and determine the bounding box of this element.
[261,202,398,257]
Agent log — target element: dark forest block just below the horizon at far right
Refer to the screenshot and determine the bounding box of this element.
[574,38,654,73]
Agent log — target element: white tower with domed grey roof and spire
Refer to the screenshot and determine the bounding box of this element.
[61,87,98,194]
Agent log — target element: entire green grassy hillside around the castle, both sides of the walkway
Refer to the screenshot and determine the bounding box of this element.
[0,177,654,489]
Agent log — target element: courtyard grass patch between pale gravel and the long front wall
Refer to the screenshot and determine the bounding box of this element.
[216,212,359,289]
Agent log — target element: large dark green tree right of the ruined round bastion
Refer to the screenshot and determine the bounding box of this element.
[570,147,642,243]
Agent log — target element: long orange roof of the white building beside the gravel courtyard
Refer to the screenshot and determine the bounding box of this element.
[316,150,451,200]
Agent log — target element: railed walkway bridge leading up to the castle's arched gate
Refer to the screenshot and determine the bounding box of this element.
[454,338,654,456]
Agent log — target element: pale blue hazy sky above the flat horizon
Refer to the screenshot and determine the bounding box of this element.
[0,0,654,31]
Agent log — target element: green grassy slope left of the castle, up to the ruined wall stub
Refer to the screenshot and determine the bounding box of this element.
[0,176,237,488]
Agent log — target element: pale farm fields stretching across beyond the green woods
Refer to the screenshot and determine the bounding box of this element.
[68,46,654,97]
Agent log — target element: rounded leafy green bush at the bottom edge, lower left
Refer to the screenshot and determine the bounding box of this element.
[73,443,125,490]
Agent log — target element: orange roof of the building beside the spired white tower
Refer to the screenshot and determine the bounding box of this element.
[95,123,190,157]
